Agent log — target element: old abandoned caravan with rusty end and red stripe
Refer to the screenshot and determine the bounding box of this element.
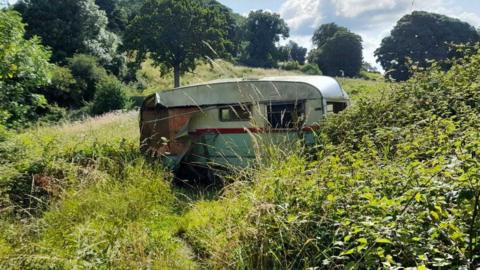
[140,76,349,168]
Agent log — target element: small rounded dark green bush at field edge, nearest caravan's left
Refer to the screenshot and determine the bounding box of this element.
[91,76,131,115]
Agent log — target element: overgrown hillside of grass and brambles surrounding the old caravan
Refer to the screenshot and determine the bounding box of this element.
[0,48,480,269]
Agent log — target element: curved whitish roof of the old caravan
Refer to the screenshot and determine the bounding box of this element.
[144,76,348,108]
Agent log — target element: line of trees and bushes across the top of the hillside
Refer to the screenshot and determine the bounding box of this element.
[0,0,480,127]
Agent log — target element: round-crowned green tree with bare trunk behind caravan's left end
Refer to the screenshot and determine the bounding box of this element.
[125,0,230,87]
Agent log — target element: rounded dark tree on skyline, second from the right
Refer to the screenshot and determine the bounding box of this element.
[309,23,363,77]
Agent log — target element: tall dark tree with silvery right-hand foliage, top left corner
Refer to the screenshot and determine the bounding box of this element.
[15,0,120,65]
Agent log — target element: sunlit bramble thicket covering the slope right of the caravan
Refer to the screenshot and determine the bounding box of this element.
[184,45,480,269]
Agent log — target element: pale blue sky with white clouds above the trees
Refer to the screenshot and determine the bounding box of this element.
[219,0,480,67]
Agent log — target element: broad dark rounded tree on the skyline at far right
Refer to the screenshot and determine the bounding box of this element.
[375,11,480,81]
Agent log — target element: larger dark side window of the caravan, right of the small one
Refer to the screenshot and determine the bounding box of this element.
[268,103,304,129]
